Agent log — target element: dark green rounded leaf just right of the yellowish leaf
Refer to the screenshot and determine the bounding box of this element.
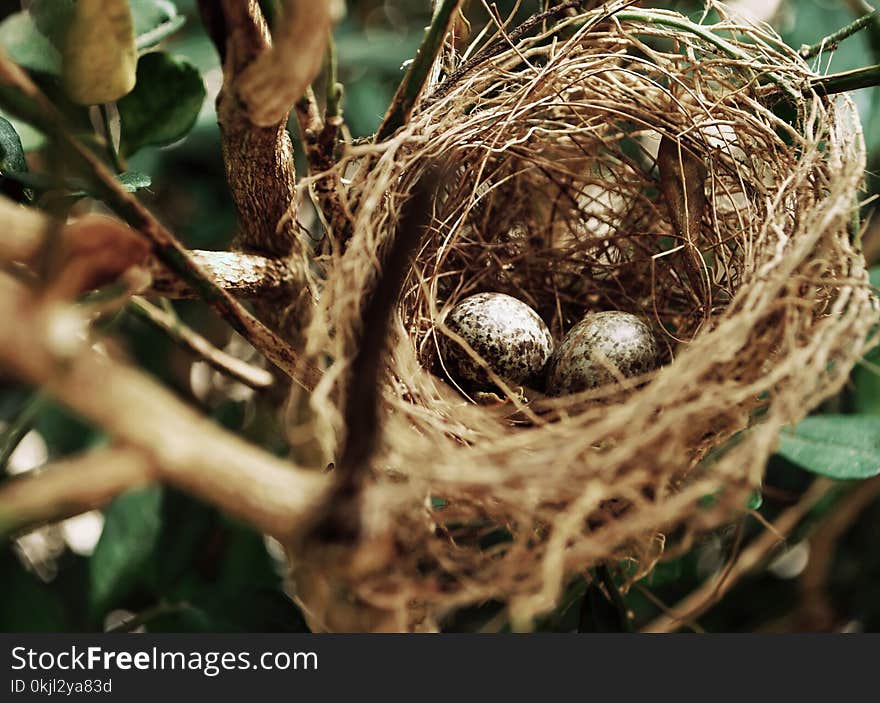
[117,52,205,156]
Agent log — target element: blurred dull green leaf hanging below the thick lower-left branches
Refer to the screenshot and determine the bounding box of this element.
[89,486,162,617]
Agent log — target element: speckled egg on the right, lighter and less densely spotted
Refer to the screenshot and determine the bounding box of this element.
[547,311,660,395]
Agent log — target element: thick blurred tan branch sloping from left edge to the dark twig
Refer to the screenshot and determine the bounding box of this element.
[0,275,327,541]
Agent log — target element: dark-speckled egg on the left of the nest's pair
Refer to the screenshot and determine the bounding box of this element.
[437,293,553,390]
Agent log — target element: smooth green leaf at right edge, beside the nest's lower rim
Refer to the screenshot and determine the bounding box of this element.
[779,415,880,479]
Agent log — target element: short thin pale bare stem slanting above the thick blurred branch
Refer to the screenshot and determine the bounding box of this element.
[129,296,274,389]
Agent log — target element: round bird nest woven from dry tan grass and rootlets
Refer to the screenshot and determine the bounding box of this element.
[295,3,878,629]
